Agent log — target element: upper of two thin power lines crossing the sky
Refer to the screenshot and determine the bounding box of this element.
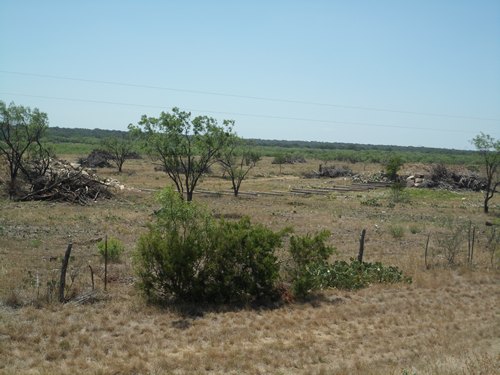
[0,70,500,122]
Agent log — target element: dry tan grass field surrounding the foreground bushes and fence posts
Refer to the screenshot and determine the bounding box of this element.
[0,155,500,374]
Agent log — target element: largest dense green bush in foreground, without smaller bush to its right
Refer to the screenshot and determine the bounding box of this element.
[135,190,285,303]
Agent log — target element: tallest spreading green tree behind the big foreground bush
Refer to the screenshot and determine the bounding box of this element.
[129,108,234,201]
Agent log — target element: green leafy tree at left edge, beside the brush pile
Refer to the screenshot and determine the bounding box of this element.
[0,101,48,199]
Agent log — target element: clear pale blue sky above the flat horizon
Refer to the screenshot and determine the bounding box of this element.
[0,0,500,149]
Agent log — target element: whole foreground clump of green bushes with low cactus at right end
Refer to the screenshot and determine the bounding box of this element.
[134,189,408,303]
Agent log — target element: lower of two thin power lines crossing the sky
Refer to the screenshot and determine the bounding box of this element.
[0,92,475,134]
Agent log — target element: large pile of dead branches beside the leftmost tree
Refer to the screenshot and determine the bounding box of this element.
[19,160,113,205]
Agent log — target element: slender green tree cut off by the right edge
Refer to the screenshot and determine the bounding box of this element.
[472,132,500,213]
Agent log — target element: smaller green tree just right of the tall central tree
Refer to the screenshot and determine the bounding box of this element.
[219,135,260,197]
